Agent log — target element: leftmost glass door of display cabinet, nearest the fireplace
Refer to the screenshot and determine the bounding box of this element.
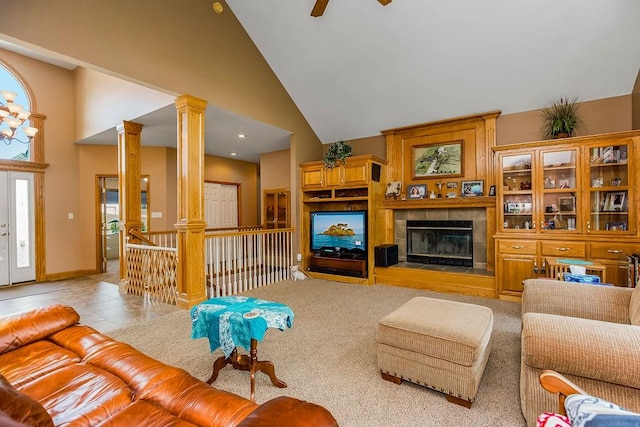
[498,153,534,232]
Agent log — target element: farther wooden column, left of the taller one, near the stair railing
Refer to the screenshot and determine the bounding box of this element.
[117,121,142,279]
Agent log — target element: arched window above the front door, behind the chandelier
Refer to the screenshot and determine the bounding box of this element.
[0,63,31,161]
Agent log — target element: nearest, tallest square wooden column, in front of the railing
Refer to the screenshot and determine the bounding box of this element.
[175,95,207,309]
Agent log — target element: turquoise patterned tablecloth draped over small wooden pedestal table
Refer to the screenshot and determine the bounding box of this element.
[191,296,293,357]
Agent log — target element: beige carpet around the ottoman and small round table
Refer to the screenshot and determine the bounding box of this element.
[109,279,525,427]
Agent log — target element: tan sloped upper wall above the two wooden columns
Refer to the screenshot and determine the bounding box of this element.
[0,0,321,258]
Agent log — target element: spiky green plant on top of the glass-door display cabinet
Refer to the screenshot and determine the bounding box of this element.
[540,98,585,139]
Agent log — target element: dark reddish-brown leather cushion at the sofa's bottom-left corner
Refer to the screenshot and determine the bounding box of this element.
[0,375,53,427]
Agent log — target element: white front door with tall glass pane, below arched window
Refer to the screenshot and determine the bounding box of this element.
[0,171,36,286]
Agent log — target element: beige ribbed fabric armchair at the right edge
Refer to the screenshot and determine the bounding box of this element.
[520,279,640,426]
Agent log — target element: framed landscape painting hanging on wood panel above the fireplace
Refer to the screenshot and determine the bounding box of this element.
[411,140,463,179]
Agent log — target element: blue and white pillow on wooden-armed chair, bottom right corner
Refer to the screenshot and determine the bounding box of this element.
[564,394,640,427]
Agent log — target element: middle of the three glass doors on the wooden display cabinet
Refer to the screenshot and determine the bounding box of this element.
[538,149,580,233]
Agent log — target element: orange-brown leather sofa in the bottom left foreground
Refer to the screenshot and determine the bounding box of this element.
[0,305,337,426]
